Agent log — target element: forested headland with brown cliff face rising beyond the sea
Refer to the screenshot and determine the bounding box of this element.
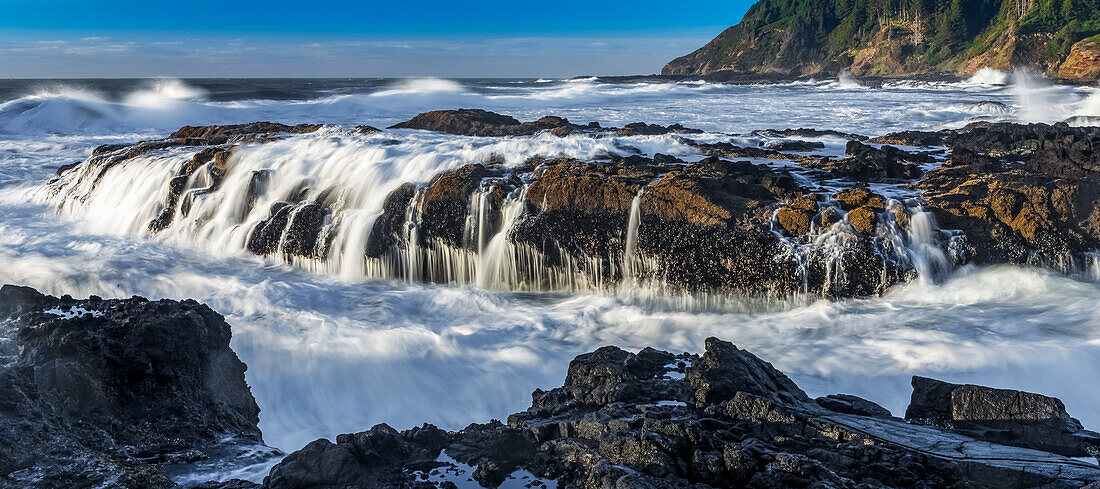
[662,0,1100,79]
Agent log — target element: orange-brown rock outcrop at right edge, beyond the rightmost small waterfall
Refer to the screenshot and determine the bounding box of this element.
[919,124,1100,267]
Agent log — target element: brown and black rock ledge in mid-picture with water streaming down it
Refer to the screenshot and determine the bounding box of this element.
[38,109,1100,298]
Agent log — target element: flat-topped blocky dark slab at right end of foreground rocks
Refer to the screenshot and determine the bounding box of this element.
[905,377,1100,457]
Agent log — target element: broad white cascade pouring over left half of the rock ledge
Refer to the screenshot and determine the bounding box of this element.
[31,127,660,290]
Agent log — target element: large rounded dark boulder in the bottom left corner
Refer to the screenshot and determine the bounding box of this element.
[0,286,274,489]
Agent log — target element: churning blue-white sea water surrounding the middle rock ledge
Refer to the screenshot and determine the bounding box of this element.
[0,70,1100,472]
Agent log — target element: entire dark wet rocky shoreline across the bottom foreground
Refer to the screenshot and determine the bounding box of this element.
[0,286,1100,489]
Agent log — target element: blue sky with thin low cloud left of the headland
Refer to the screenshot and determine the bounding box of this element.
[0,0,751,78]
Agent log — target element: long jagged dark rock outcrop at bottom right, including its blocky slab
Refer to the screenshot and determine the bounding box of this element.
[238,338,1100,489]
